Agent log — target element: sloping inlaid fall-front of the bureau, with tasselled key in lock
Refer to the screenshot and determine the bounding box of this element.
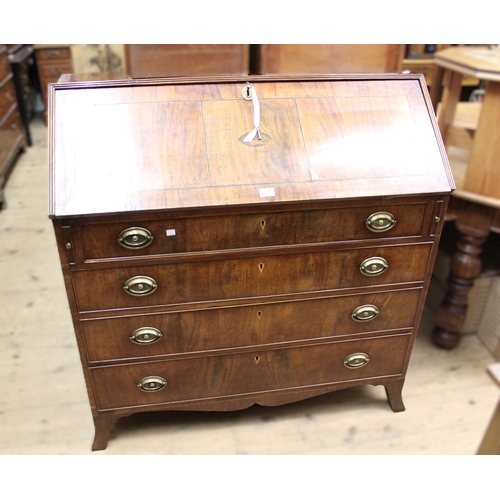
[49,75,454,217]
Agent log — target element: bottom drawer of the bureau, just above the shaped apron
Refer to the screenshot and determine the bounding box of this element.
[90,334,411,410]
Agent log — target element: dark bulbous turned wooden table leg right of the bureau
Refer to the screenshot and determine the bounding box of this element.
[432,200,493,349]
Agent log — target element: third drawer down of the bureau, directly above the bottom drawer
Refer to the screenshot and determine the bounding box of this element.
[81,288,421,362]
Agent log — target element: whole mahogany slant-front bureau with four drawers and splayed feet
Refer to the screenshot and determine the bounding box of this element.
[49,74,454,450]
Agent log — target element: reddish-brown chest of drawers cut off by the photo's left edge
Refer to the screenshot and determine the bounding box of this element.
[0,44,26,207]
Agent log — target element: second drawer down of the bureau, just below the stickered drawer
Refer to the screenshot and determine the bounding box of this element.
[72,243,432,311]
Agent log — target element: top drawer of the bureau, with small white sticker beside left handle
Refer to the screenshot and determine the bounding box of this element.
[81,203,427,260]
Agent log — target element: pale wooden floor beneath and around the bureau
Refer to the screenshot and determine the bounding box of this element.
[0,118,499,455]
